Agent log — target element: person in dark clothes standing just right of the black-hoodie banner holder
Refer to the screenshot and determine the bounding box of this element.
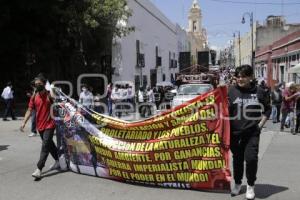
[271,84,282,123]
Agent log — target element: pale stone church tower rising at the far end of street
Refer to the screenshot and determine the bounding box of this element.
[187,0,207,63]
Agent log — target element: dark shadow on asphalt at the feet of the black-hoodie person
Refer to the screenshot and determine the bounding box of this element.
[241,184,289,199]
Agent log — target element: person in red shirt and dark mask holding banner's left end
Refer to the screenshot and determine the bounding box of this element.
[20,76,59,178]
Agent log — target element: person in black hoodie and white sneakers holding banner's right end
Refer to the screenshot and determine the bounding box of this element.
[228,65,271,199]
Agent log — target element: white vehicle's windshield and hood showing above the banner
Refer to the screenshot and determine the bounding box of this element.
[172,83,214,108]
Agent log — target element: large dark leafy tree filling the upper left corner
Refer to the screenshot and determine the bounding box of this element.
[0,0,134,100]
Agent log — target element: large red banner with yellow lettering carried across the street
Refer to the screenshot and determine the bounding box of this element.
[56,87,231,191]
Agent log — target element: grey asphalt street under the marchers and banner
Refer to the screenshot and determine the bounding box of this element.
[0,120,300,200]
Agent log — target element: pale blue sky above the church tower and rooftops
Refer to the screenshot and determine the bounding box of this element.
[151,0,300,47]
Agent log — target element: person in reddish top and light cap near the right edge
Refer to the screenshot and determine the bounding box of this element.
[280,82,300,134]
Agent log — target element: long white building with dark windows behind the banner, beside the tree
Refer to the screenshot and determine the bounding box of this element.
[112,0,179,87]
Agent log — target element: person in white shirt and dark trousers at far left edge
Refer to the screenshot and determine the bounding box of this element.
[1,82,17,121]
